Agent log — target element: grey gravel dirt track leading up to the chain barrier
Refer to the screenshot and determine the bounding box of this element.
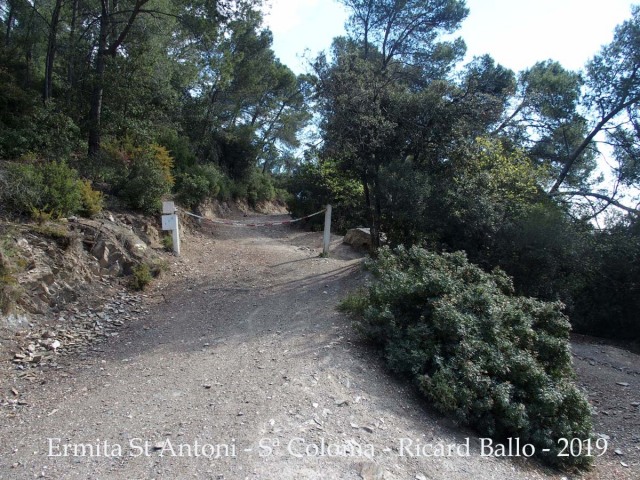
[0,216,640,480]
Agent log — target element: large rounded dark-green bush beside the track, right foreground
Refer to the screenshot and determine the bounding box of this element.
[344,247,591,468]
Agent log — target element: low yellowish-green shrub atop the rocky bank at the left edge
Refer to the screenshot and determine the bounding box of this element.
[0,162,83,220]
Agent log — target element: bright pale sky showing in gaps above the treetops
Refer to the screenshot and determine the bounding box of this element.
[265,0,640,73]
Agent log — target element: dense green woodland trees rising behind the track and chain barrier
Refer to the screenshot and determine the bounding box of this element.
[0,0,640,342]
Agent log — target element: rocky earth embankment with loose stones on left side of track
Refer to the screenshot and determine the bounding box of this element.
[0,212,166,396]
